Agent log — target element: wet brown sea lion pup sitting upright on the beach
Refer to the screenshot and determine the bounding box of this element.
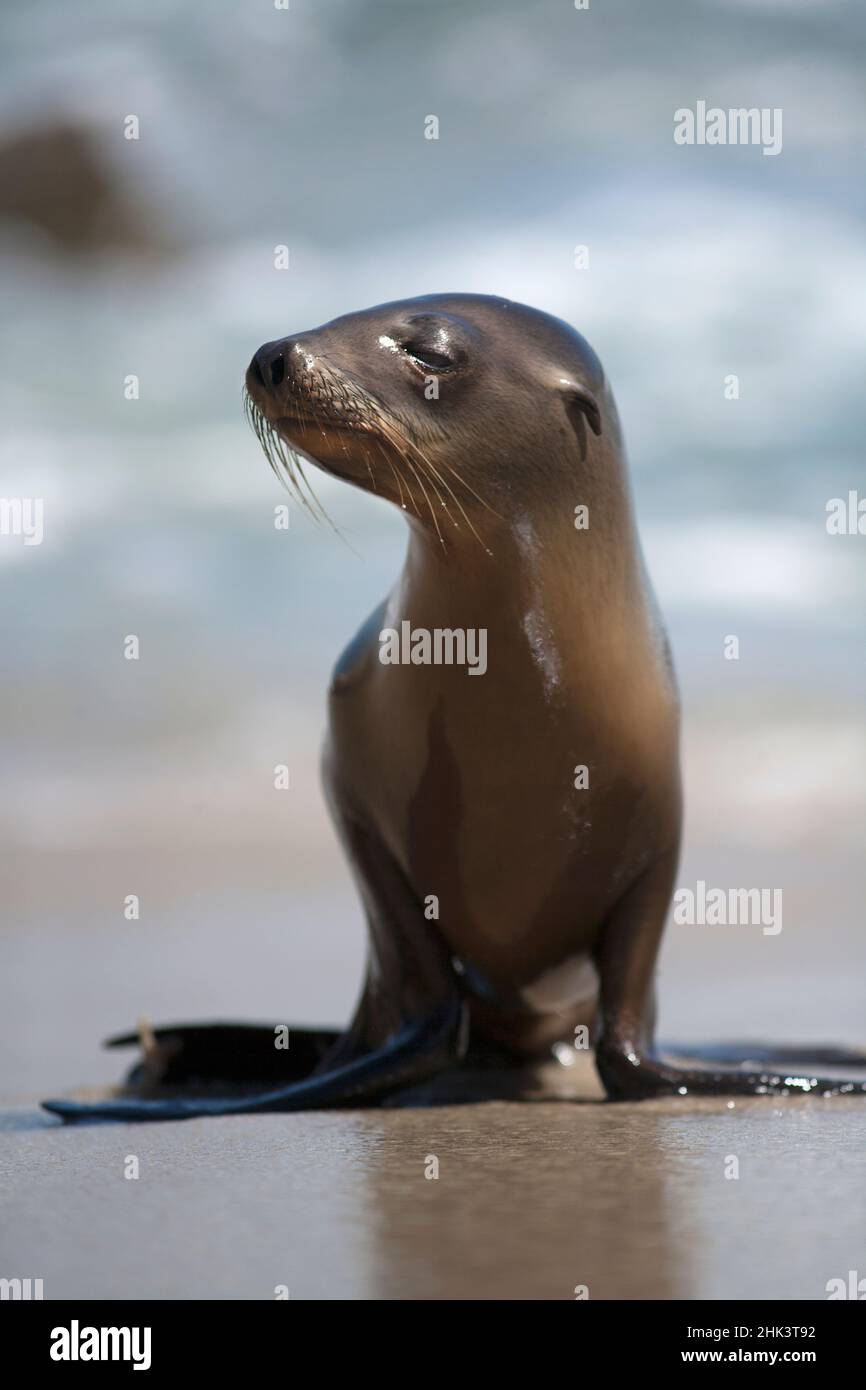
[46,295,863,1119]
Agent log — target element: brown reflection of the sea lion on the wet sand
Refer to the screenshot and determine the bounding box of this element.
[368,1059,691,1300]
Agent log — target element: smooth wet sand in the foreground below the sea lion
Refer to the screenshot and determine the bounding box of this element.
[1,1098,866,1300]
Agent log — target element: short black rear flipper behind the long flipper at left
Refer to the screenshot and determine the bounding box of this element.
[106,1022,339,1095]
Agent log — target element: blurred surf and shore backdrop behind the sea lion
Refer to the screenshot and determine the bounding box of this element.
[0,0,866,1095]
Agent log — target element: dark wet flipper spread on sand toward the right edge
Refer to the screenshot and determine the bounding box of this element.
[596,1041,866,1101]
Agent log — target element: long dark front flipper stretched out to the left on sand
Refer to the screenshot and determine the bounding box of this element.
[42,995,466,1120]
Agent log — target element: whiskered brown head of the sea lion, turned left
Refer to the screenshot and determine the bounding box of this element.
[246,295,620,539]
